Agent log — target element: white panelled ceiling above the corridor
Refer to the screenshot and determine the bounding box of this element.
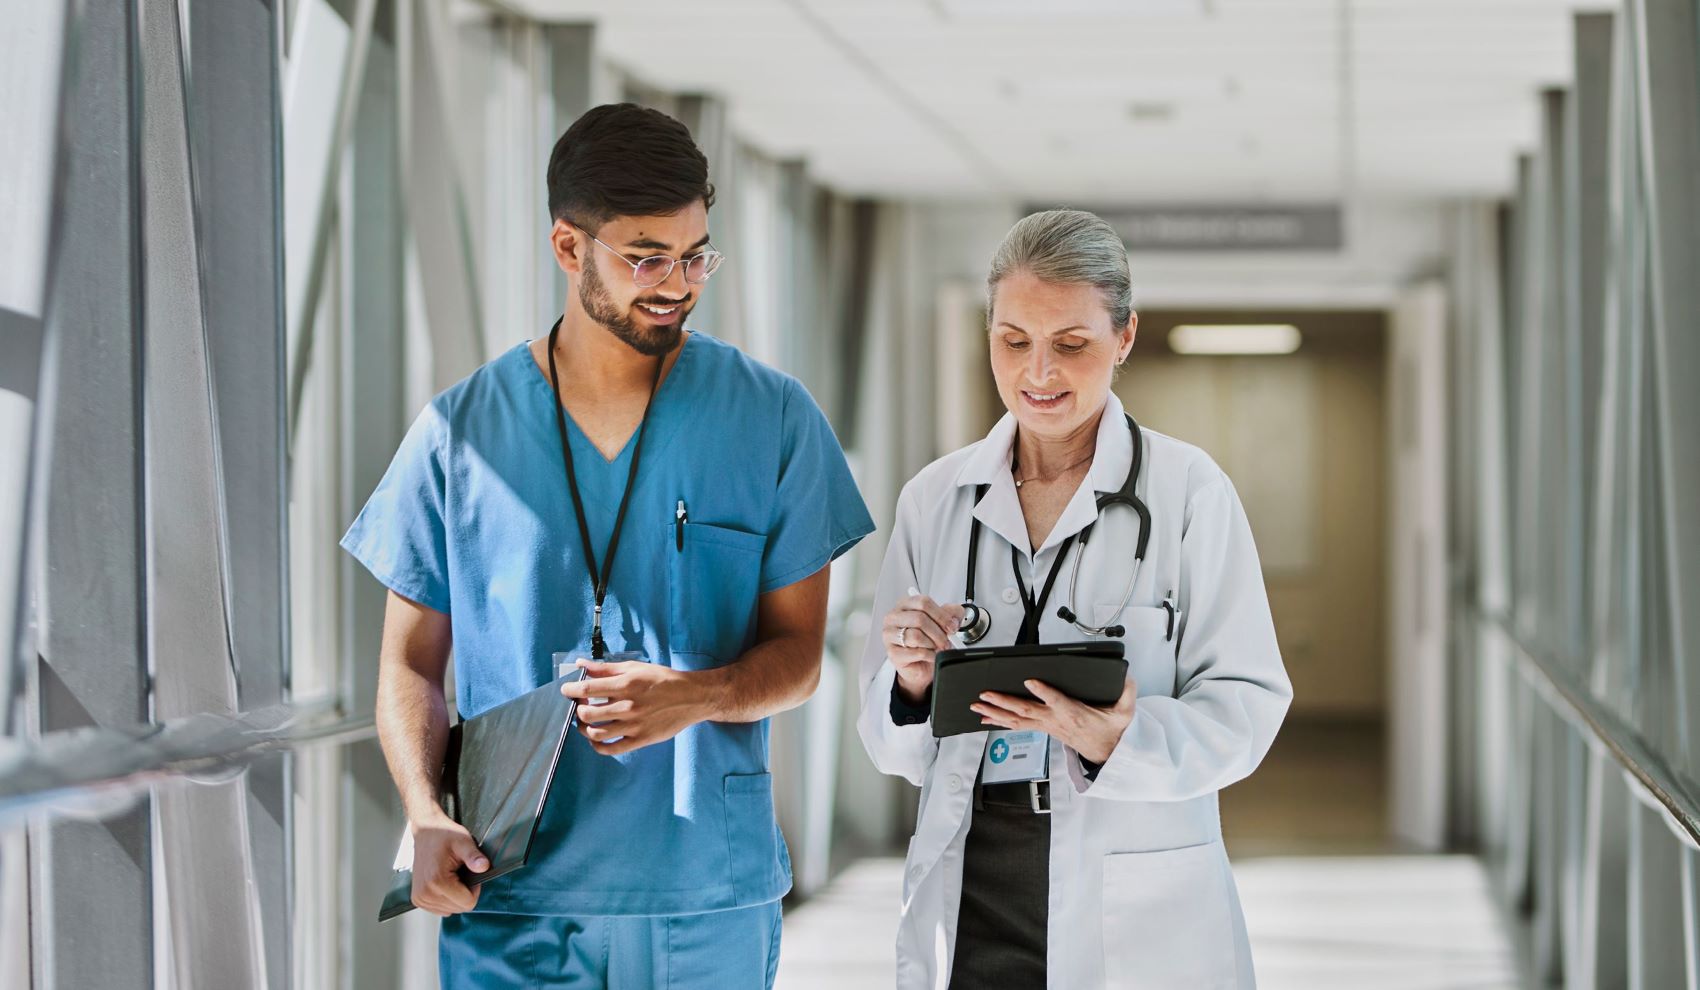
[508,0,1600,204]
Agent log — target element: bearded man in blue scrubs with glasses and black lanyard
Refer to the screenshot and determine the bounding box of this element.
[342,104,874,990]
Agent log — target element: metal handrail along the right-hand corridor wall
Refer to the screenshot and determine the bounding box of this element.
[1472,609,1700,851]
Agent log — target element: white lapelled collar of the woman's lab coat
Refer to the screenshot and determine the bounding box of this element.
[955,391,1134,568]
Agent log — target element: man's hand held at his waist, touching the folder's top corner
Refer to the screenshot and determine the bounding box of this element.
[561,660,714,755]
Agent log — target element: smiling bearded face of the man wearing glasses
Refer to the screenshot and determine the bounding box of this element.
[553,201,709,357]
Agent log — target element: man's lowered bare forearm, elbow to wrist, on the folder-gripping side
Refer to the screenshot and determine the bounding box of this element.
[377,665,449,822]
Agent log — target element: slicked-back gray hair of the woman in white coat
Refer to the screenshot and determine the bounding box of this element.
[986,209,1134,328]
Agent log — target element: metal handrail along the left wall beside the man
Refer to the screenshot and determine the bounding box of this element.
[0,697,377,830]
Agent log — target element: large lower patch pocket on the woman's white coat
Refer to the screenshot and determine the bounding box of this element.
[1103,840,1238,990]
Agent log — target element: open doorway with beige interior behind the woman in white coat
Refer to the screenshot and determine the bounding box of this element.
[1115,310,1389,856]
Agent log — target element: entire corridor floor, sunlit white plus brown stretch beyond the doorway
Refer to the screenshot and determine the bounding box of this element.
[779,723,1520,990]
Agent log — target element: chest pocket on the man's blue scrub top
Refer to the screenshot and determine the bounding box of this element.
[668,522,767,665]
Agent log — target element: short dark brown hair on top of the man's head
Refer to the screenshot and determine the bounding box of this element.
[547,104,714,231]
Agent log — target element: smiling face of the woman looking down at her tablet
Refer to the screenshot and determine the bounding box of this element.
[989,269,1139,439]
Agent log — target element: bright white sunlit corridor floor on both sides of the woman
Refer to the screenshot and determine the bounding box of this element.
[779,856,1518,990]
